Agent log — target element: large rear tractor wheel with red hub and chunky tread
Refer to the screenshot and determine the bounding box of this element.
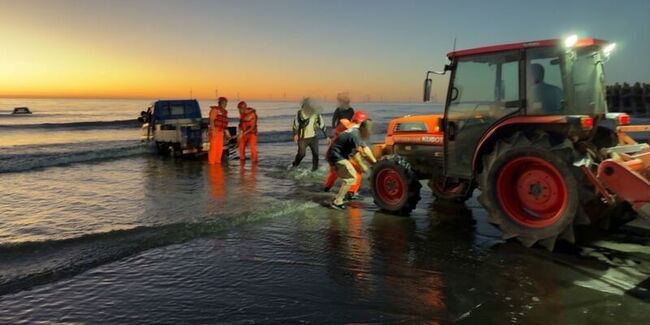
[479,132,580,250]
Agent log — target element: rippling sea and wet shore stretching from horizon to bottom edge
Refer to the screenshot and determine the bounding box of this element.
[0,99,650,324]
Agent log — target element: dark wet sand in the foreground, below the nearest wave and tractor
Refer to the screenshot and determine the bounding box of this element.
[0,186,650,324]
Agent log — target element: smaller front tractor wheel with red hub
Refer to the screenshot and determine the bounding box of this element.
[370,155,422,215]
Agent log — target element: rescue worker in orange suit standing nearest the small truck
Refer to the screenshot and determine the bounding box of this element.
[208,97,230,165]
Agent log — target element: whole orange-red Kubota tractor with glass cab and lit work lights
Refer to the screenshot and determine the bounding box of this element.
[371,36,650,249]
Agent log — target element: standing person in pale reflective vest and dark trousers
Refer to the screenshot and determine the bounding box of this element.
[290,97,326,171]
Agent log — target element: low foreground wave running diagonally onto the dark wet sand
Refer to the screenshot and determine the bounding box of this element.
[0,200,317,296]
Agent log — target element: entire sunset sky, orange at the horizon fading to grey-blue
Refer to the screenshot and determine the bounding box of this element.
[0,0,650,101]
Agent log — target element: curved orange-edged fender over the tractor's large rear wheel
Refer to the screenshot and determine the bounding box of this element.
[472,115,567,173]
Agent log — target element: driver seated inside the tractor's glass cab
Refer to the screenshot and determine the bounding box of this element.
[530,63,563,114]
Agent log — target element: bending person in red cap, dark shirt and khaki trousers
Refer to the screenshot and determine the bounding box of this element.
[326,111,377,210]
